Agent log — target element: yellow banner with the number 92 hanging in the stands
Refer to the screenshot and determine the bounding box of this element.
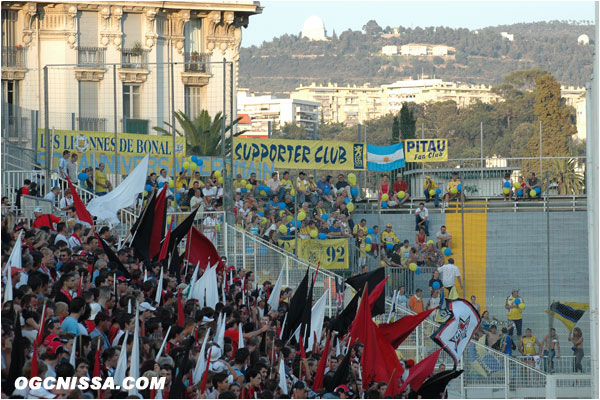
[279,239,350,269]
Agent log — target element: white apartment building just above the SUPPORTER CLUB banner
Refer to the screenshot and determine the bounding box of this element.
[237,90,321,137]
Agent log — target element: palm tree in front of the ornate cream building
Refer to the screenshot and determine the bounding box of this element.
[153,110,246,156]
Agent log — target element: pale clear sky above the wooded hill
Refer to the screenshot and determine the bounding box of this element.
[242,0,595,47]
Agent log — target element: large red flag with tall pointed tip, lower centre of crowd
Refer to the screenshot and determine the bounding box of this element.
[350,284,404,394]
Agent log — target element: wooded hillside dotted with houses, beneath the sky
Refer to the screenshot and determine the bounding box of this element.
[239,21,595,93]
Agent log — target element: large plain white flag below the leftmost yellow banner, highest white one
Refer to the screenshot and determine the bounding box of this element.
[87,154,150,225]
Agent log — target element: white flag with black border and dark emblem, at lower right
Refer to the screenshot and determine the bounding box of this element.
[431,299,481,363]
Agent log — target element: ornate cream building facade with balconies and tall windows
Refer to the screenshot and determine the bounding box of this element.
[2,1,262,146]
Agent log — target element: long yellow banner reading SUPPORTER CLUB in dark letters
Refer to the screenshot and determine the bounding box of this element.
[233,138,367,171]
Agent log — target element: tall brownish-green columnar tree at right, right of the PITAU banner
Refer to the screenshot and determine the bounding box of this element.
[527,74,577,157]
